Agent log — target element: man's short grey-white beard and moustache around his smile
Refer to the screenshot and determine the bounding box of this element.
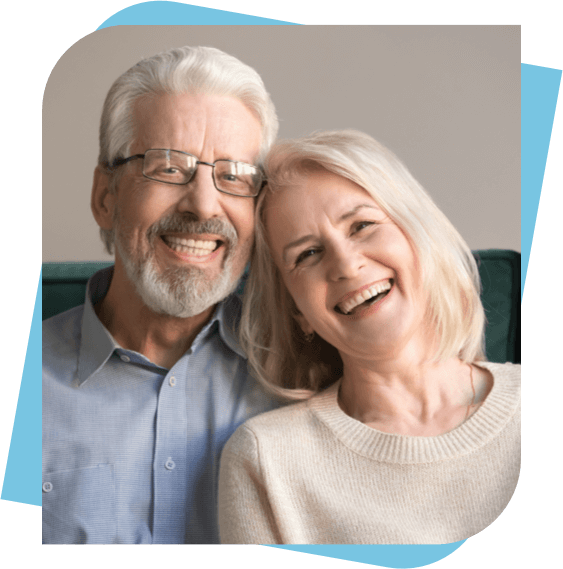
[114,212,242,318]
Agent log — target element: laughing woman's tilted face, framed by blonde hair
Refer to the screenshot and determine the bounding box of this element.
[264,170,427,358]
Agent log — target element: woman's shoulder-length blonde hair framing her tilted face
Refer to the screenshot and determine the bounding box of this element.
[240,130,486,399]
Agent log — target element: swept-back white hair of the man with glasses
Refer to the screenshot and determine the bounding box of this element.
[98,47,279,254]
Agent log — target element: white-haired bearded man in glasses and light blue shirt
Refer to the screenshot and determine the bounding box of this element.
[43,48,278,544]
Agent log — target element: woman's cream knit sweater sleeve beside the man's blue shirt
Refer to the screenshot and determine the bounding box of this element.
[218,425,282,545]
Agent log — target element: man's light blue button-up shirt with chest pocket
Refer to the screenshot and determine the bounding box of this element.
[42,267,278,545]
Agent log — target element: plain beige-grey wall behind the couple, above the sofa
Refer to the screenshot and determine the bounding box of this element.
[42,24,520,262]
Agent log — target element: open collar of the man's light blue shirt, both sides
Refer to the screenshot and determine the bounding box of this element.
[77,266,246,384]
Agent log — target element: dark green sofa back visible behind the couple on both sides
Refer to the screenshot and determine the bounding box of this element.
[42,249,521,363]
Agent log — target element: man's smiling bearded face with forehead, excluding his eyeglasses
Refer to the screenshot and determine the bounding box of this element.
[108,94,261,318]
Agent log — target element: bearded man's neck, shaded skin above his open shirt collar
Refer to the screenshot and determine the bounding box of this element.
[94,265,215,369]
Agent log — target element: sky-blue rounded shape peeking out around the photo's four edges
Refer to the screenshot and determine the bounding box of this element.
[14,13,552,569]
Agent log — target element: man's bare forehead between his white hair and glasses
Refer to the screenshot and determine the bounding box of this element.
[132,93,262,161]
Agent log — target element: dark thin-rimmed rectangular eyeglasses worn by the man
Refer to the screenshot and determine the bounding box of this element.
[111,148,266,198]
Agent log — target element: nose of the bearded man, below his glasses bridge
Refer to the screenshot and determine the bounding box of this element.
[178,163,227,219]
